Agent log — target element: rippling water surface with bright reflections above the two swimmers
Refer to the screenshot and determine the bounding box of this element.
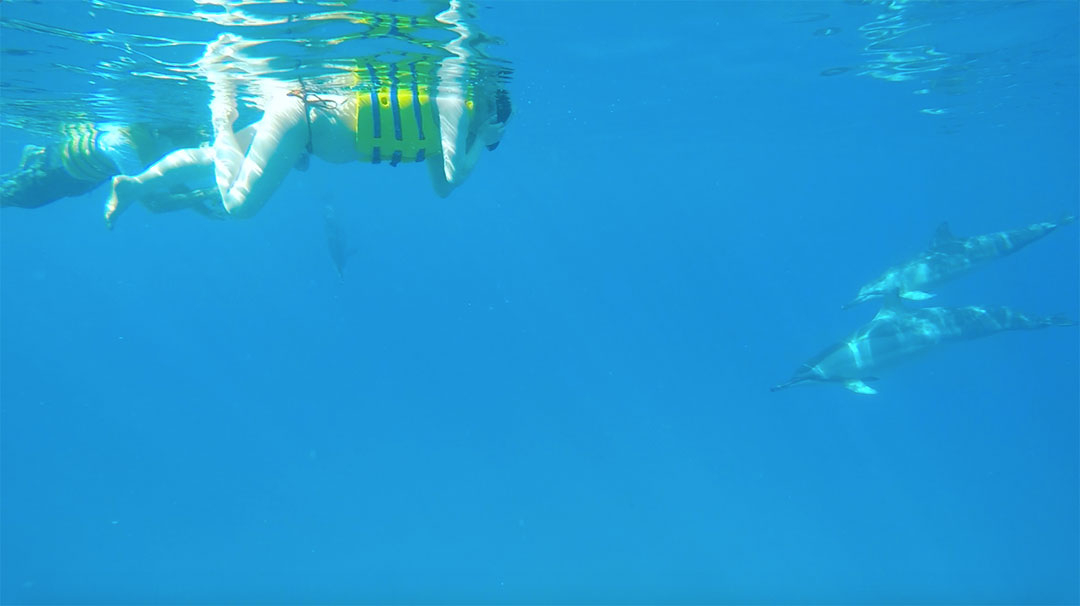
[0,0,511,133]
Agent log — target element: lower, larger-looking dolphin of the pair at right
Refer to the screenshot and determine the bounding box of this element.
[772,293,1076,394]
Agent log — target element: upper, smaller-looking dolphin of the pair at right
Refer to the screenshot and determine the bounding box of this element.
[843,216,1076,309]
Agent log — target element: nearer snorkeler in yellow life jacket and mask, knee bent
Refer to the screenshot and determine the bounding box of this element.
[105,4,511,227]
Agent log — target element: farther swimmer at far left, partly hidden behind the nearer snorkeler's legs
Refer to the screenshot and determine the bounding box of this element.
[0,123,220,212]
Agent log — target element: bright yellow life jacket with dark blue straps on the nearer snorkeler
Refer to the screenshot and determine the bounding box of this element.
[355,64,473,166]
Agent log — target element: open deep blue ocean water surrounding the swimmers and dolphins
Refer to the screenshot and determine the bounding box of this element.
[0,1,1080,604]
